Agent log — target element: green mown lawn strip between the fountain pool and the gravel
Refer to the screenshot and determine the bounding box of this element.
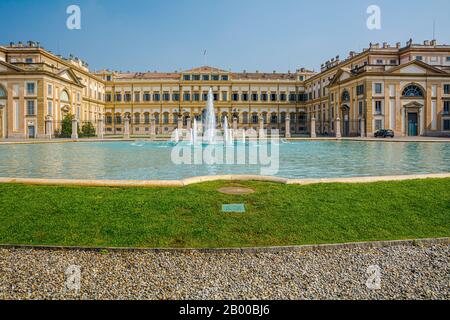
[0,179,450,248]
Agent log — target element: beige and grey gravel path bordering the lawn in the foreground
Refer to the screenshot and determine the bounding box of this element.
[0,245,450,300]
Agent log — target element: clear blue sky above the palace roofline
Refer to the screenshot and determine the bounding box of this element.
[0,0,450,72]
